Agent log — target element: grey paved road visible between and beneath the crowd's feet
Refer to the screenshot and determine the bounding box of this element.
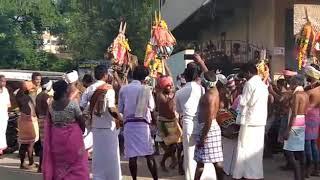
[0,154,320,180]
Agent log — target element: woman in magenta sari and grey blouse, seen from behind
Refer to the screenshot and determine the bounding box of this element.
[43,81,89,180]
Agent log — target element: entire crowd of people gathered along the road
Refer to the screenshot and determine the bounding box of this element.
[0,54,320,180]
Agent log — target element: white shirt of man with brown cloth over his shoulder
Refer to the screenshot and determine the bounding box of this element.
[80,81,116,129]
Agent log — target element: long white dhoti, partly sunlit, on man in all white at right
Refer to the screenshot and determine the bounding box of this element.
[233,125,265,179]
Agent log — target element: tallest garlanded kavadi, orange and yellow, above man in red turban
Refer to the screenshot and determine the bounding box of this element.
[144,12,176,78]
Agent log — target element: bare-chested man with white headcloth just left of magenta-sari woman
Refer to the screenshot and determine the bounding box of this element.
[35,77,53,172]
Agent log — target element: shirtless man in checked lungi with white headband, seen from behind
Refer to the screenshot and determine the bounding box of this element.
[194,71,224,180]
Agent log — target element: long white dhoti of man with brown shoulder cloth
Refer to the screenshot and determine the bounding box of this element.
[92,128,122,180]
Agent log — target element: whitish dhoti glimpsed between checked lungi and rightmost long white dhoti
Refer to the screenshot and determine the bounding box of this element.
[222,137,238,176]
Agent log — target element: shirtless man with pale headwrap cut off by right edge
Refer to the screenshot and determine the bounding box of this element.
[305,66,320,177]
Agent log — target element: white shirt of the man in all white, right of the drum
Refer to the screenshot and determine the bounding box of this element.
[239,75,269,126]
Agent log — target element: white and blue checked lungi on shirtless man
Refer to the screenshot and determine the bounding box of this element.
[194,120,223,163]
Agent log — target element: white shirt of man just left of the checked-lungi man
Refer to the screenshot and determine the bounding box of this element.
[176,82,205,134]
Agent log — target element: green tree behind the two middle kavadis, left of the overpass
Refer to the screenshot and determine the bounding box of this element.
[60,0,155,60]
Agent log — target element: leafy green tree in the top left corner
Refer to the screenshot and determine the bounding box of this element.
[0,0,71,71]
